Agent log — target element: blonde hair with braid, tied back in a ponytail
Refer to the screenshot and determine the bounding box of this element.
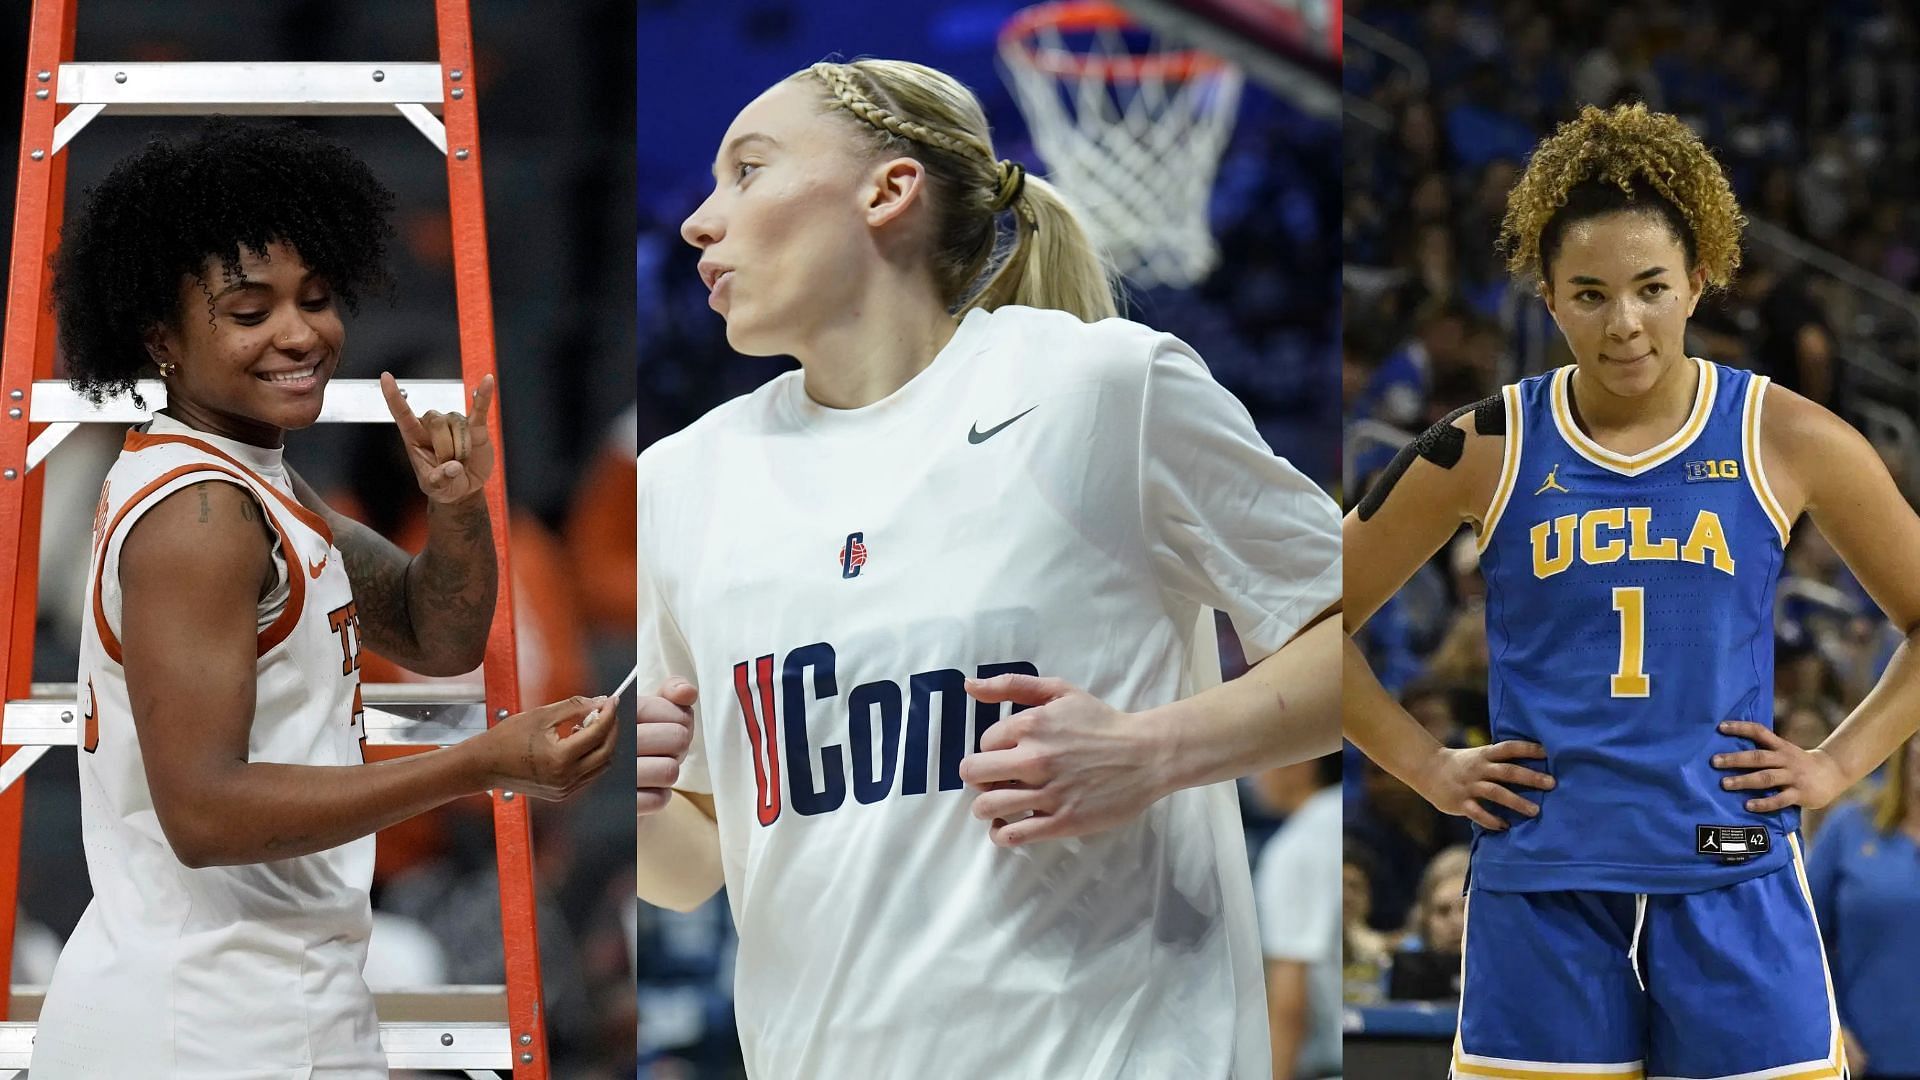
[791,60,1117,323]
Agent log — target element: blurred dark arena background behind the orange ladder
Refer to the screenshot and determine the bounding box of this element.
[0,0,636,1078]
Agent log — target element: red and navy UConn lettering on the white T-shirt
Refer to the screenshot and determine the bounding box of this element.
[733,642,1039,824]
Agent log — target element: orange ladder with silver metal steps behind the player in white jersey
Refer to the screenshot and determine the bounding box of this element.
[0,0,547,1080]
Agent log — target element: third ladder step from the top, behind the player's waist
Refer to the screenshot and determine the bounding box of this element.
[0,682,486,746]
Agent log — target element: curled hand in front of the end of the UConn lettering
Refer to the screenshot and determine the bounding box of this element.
[960,675,1169,847]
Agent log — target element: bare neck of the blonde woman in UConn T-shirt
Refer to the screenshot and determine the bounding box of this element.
[793,281,958,409]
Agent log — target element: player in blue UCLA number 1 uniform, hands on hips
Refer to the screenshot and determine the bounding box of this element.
[1344,106,1920,1080]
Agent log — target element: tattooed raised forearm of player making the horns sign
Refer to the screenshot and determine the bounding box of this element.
[407,494,499,675]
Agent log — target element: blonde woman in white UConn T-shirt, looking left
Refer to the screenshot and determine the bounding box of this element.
[637,60,1340,1080]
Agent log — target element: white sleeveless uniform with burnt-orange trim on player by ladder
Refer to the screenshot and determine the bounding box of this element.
[33,407,386,1080]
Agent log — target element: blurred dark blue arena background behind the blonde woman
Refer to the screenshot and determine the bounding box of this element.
[636,0,1340,1078]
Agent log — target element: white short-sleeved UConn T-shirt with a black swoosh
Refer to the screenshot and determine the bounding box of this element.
[639,307,1340,1080]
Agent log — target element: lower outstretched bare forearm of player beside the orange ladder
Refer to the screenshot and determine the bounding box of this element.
[156,744,490,869]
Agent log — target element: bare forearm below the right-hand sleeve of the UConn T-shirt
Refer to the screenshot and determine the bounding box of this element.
[1144,613,1340,790]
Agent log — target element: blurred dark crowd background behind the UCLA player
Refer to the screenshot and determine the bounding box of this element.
[1342,0,1920,1080]
